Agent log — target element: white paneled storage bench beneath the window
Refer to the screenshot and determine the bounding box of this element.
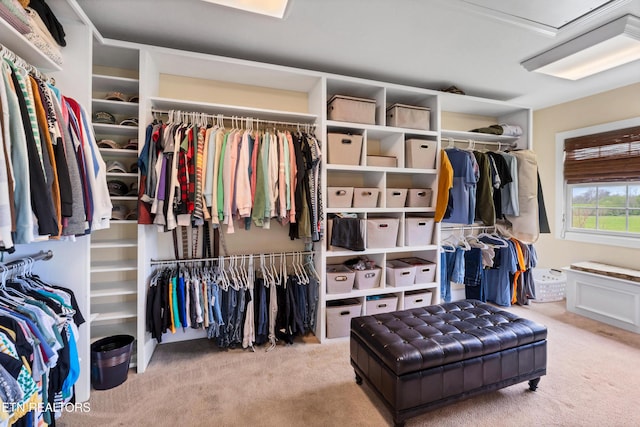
[564,262,640,333]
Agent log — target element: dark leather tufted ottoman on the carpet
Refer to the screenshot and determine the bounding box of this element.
[351,300,547,426]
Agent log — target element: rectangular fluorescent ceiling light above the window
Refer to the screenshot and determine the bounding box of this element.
[521,15,640,80]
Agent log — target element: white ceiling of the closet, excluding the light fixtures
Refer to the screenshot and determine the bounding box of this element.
[77,0,640,109]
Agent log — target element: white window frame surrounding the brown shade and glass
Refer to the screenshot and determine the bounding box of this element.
[554,117,640,248]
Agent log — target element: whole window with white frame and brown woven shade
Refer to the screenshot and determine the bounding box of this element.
[556,119,640,247]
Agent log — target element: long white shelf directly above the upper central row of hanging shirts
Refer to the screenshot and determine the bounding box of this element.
[149,97,318,124]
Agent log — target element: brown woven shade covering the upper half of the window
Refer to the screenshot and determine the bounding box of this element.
[564,126,640,184]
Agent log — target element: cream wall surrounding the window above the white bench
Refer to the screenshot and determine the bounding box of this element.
[533,83,640,268]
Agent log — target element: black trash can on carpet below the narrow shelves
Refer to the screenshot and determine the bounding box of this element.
[91,335,135,390]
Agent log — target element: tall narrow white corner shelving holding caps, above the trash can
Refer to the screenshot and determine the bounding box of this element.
[90,43,139,366]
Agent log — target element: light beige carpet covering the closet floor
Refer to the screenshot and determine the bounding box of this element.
[58,302,640,427]
